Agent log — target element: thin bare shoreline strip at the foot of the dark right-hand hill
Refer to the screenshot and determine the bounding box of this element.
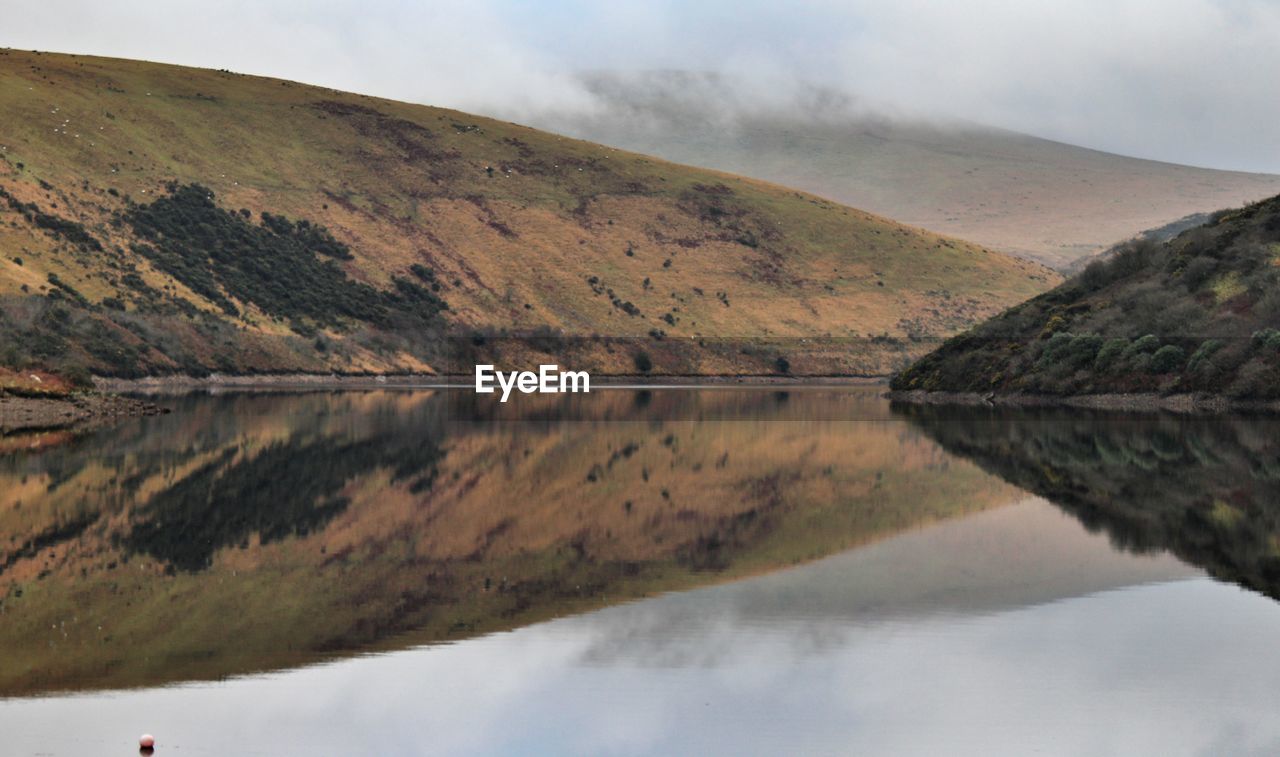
[884,389,1280,414]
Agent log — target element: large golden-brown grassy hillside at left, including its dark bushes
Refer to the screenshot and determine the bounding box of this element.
[0,50,1056,375]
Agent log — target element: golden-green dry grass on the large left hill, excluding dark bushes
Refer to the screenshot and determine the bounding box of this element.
[0,50,1059,370]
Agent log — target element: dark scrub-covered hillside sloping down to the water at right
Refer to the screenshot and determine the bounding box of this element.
[893,192,1280,400]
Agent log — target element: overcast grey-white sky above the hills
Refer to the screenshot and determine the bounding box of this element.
[0,0,1280,172]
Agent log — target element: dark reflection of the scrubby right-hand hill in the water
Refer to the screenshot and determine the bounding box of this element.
[904,407,1280,598]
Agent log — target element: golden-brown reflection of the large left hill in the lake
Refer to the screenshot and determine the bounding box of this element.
[0,391,1018,694]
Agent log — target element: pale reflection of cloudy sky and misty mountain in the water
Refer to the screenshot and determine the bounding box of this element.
[0,501,1280,754]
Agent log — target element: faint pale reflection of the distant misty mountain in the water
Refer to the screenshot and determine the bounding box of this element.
[573,497,1198,667]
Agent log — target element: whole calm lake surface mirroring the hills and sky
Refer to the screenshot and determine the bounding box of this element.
[0,388,1280,754]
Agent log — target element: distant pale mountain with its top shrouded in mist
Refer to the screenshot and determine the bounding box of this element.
[522,72,1280,269]
